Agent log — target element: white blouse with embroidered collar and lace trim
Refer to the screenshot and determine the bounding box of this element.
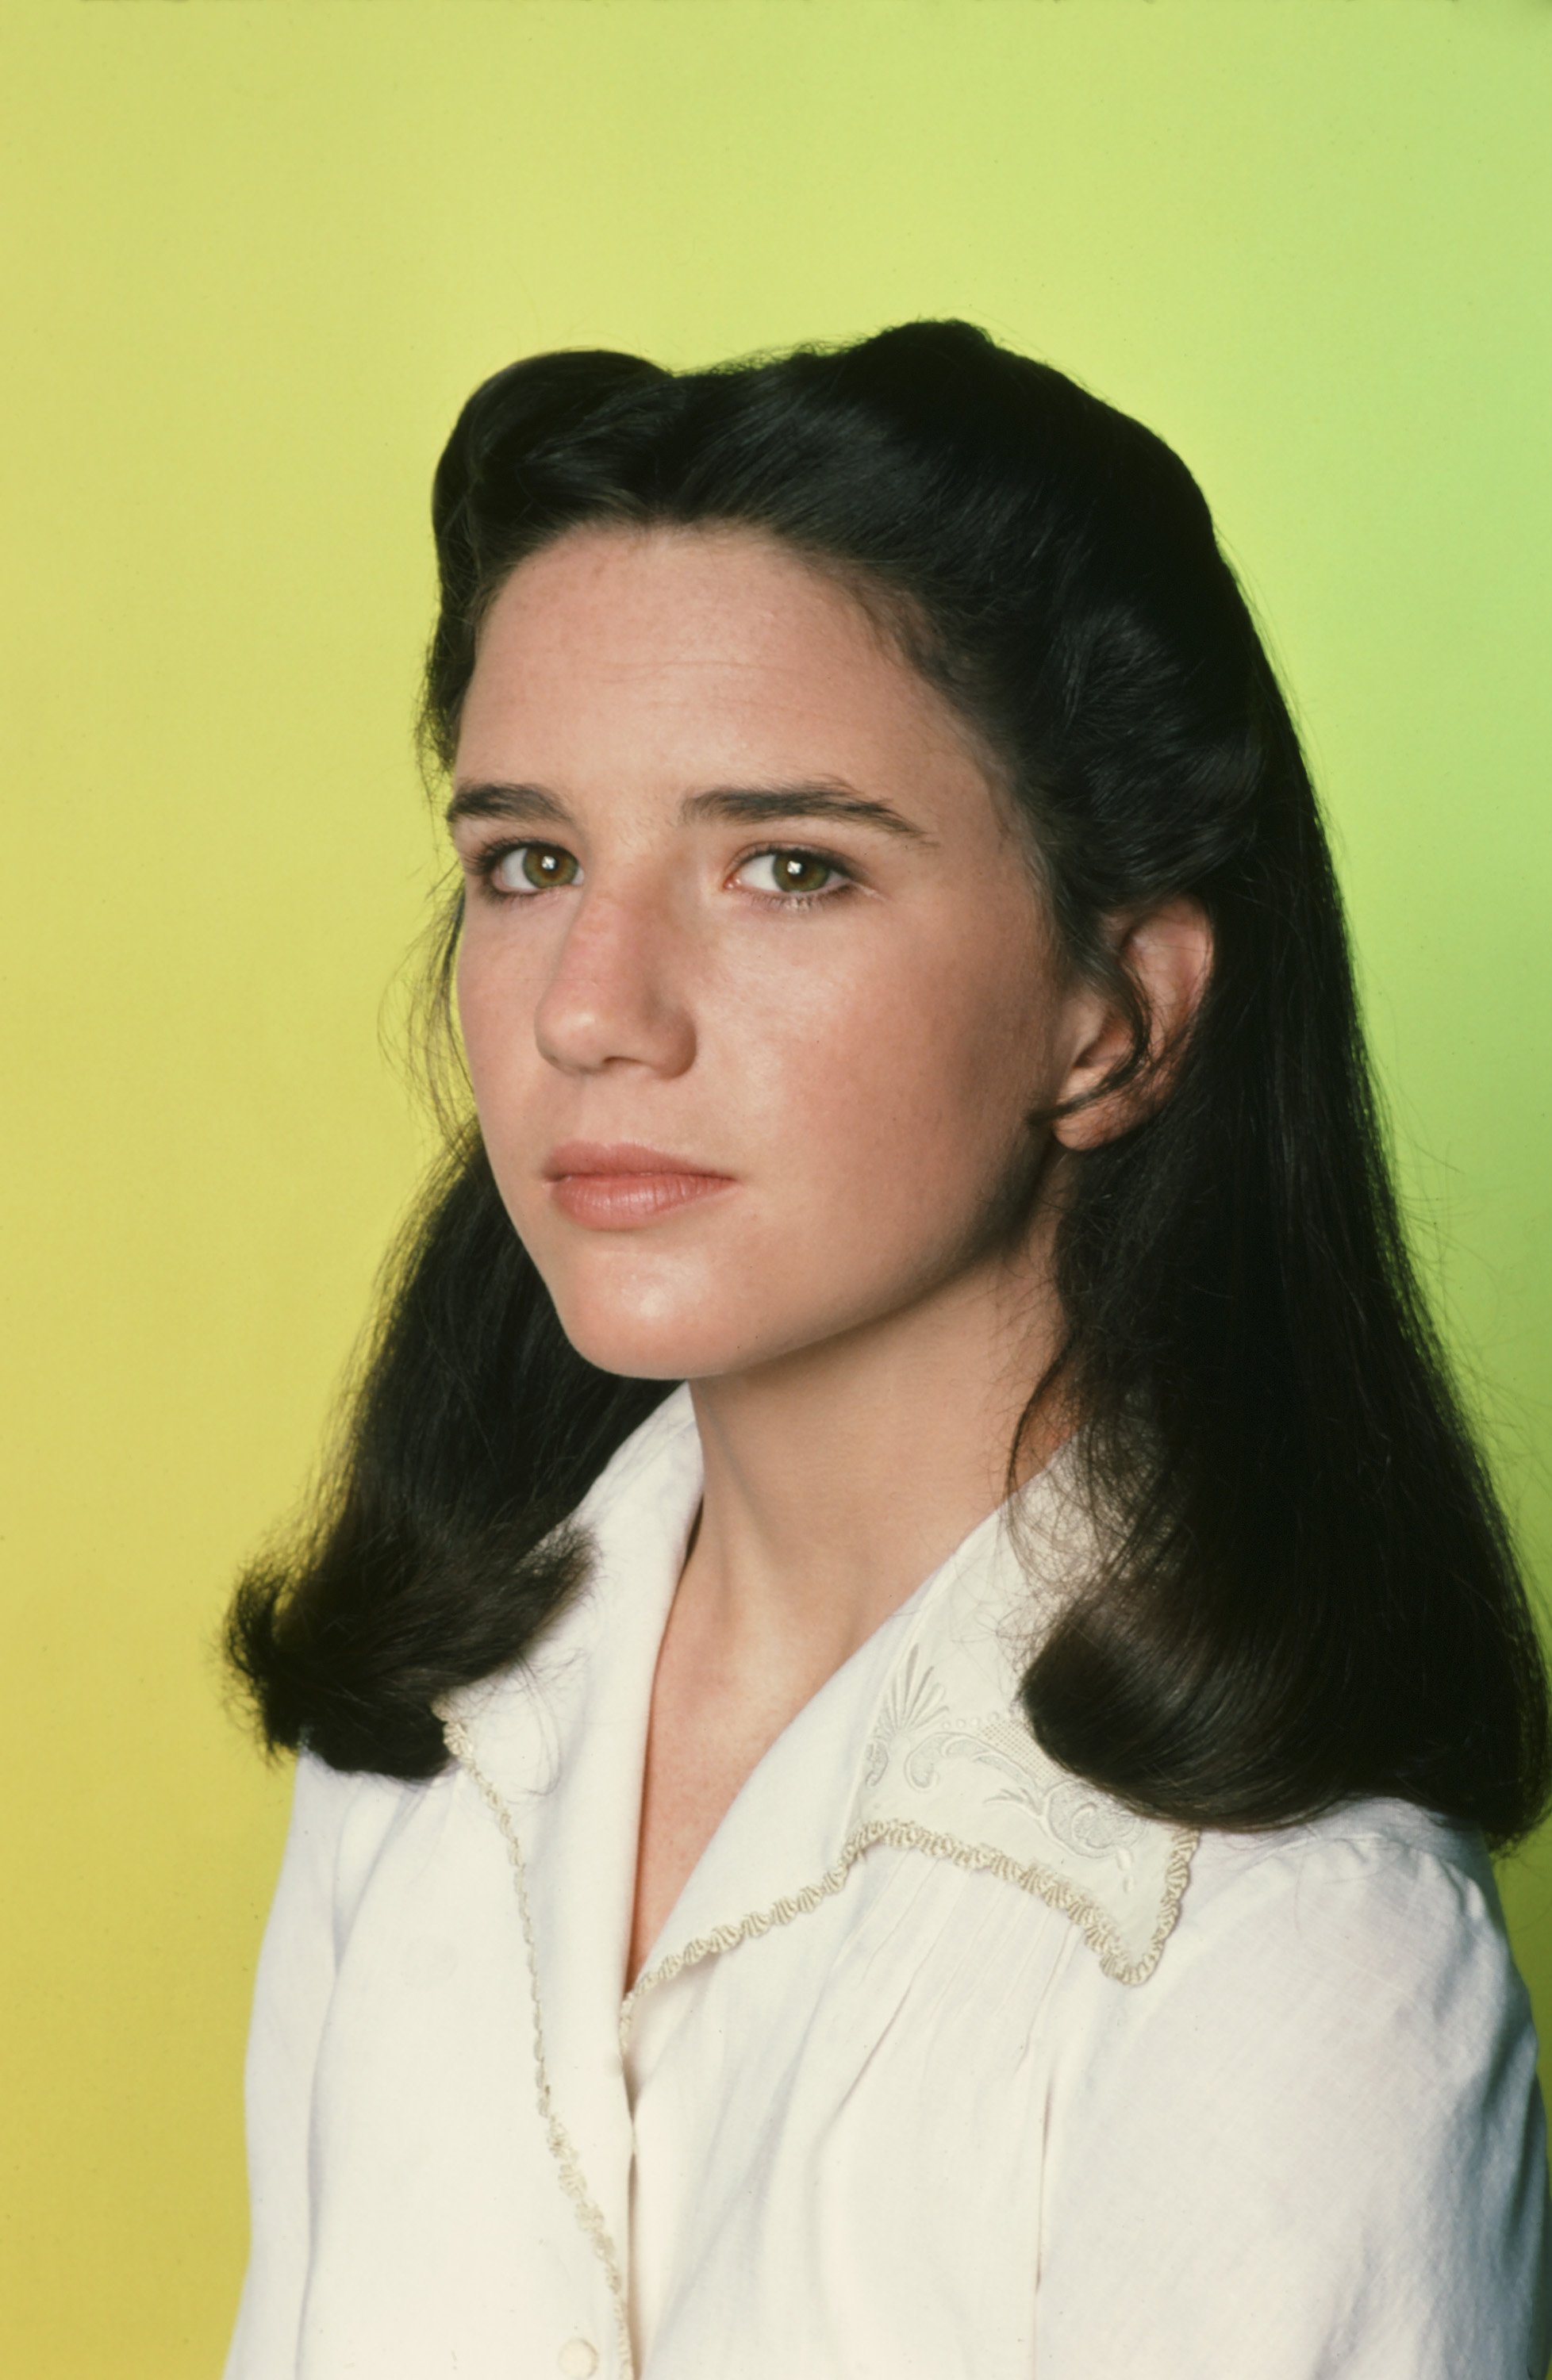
[226,1388,1552,2380]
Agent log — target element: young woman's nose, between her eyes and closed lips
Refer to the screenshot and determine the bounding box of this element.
[533,888,695,1076]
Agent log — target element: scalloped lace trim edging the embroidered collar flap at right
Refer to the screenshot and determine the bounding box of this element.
[619,1818,1202,2044]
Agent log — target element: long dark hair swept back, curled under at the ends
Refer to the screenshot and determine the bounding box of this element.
[229,321,1552,1847]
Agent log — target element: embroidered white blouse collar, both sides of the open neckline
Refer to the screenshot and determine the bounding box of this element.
[443,1385,1197,2021]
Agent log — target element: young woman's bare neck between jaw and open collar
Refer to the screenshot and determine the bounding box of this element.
[678,1209,1066,1690]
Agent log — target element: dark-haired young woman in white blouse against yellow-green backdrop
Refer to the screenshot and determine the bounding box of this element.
[229,321,1550,2380]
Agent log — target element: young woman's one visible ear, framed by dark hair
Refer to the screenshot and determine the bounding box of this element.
[1052,895,1212,1150]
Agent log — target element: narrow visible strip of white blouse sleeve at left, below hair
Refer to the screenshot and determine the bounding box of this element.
[226,1752,359,2380]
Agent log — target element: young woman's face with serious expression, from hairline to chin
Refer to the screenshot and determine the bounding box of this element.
[450,528,1085,1378]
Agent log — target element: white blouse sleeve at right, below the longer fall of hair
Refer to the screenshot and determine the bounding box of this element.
[1040,1835,1552,2380]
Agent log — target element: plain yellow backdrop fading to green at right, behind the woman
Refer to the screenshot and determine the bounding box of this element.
[0,0,1552,2380]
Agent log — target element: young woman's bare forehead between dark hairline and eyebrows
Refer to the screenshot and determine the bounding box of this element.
[457,526,990,774]
